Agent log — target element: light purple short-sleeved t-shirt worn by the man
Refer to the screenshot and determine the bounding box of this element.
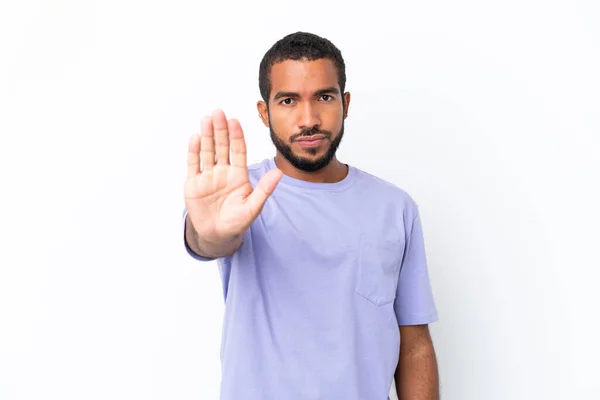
[184,159,438,400]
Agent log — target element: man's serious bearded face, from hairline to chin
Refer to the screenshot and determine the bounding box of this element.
[268,59,349,172]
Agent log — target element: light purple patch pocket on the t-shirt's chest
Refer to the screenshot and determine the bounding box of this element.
[354,235,404,306]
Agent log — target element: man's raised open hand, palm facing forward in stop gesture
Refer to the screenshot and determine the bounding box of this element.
[184,110,282,247]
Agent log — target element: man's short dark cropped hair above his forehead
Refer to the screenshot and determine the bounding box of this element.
[258,32,346,106]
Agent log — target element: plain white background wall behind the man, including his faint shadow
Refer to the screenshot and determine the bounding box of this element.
[0,0,600,400]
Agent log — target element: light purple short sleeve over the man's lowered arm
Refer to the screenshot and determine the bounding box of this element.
[394,209,438,325]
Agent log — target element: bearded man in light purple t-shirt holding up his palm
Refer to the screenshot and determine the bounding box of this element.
[184,32,439,400]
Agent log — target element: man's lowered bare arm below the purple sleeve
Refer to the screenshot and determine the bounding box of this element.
[394,324,440,400]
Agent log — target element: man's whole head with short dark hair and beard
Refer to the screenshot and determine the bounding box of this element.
[257,32,350,172]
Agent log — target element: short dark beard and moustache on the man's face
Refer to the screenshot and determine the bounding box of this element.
[269,117,344,172]
